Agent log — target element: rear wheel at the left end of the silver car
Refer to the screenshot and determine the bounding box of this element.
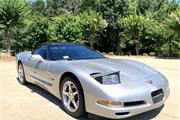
[18,62,27,85]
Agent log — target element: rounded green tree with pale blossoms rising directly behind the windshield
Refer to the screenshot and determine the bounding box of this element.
[79,10,106,49]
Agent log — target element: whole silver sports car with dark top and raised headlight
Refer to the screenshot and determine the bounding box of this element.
[17,43,170,119]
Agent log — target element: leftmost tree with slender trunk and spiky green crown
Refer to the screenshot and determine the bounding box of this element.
[0,0,29,55]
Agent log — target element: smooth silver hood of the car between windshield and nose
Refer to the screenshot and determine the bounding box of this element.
[64,58,157,80]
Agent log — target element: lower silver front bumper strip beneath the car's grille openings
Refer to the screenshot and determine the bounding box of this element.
[87,88,170,119]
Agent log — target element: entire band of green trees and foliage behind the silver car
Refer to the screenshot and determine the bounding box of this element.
[0,0,180,57]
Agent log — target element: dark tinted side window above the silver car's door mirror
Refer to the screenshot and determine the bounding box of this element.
[34,47,47,60]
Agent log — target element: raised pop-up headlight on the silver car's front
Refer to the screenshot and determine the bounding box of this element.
[91,72,120,85]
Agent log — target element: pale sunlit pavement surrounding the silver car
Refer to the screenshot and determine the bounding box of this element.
[0,56,180,120]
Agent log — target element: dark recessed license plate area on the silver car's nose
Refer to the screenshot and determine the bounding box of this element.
[151,89,164,104]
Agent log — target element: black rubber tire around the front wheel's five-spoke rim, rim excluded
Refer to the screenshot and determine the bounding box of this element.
[60,77,86,118]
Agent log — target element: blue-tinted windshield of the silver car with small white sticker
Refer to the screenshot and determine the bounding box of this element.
[49,44,104,60]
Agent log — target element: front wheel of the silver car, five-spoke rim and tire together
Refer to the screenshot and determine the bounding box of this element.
[61,77,85,118]
